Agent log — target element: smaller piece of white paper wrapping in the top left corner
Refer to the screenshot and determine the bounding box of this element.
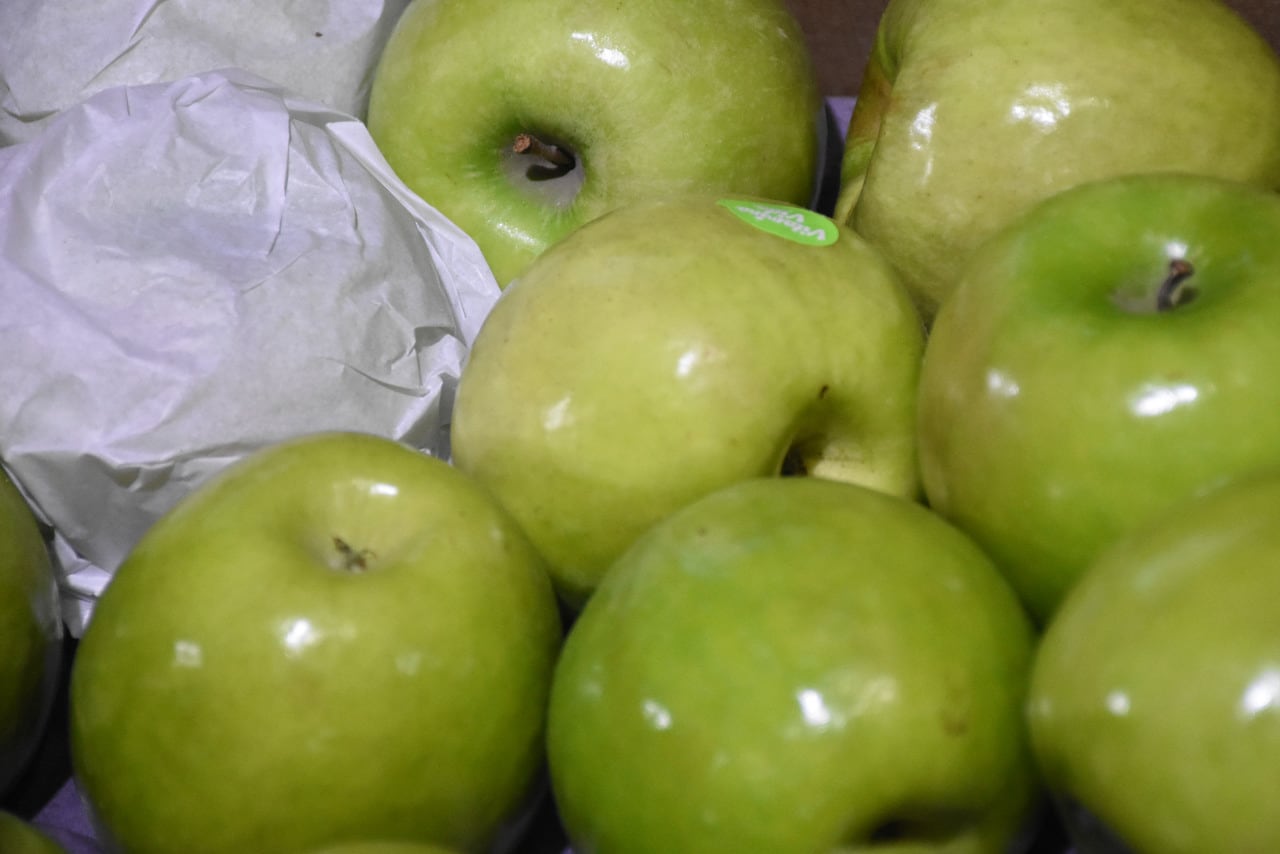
[0,0,408,145]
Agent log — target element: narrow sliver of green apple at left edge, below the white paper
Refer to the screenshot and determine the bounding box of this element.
[0,469,63,795]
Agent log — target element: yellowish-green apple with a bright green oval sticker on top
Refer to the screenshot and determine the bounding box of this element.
[452,195,923,608]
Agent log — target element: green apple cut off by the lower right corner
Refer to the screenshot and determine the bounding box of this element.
[1028,470,1280,854]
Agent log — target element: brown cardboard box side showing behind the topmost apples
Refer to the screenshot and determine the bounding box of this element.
[787,0,1280,96]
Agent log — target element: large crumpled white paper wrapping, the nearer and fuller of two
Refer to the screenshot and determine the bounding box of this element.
[0,70,498,635]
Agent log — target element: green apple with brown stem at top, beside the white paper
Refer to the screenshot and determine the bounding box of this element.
[369,0,823,286]
